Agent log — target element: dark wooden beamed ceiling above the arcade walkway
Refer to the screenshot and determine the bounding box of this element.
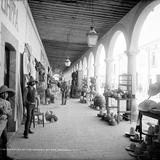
[28,0,140,71]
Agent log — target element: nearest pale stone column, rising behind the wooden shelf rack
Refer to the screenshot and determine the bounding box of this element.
[126,50,138,121]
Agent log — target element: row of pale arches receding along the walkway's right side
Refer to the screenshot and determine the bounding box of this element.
[64,0,160,114]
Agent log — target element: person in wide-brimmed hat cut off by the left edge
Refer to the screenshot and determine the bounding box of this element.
[0,85,15,160]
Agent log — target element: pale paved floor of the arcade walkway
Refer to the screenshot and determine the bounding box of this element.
[8,99,134,160]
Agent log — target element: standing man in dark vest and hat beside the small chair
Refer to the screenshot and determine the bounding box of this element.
[24,76,37,138]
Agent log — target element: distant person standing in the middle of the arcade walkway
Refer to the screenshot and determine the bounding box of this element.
[60,81,69,105]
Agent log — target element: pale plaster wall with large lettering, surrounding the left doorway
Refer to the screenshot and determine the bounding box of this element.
[0,0,49,130]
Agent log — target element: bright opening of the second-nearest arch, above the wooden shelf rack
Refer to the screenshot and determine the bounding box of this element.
[107,30,128,88]
